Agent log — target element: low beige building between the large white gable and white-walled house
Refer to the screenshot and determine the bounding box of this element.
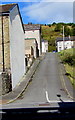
[25,38,39,66]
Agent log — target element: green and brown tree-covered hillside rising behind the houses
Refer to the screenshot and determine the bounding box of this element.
[41,22,75,52]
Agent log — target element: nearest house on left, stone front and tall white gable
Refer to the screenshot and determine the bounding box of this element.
[0,4,25,94]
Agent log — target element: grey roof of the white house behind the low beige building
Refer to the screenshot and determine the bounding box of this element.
[24,24,41,31]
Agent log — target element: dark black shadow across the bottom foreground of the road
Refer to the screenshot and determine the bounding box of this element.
[0,101,75,120]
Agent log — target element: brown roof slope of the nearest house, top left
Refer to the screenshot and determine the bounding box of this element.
[0,3,17,13]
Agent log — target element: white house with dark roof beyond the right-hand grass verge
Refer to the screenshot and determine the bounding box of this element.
[56,36,75,52]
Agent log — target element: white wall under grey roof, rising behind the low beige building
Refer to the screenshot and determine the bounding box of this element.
[25,30,41,55]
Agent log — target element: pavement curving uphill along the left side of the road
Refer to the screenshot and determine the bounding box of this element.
[0,54,45,105]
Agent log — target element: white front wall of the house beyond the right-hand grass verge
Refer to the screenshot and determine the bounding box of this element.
[57,41,73,52]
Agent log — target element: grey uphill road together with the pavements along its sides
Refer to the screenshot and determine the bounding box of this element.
[0,53,75,107]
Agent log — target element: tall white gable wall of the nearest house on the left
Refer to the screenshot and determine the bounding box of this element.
[9,6,25,88]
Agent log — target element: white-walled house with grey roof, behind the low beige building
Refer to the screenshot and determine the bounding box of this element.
[24,23,42,55]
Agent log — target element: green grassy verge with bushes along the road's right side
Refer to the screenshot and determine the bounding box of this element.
[59,48,75,86]
